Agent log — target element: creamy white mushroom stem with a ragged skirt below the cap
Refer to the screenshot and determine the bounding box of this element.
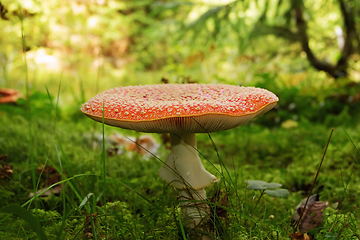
[159,133,217,227]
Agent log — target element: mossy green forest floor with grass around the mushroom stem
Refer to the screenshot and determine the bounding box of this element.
[0,87,360,239]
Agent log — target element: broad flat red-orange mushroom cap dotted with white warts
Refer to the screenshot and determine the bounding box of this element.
[81,84,279,133]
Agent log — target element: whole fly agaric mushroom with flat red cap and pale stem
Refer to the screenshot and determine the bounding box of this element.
[81,84,279,227]
